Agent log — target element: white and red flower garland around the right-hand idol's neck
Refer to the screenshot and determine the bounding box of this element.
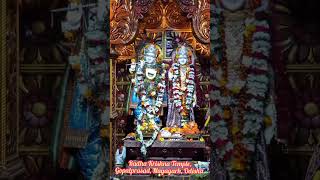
[172,63,195,120]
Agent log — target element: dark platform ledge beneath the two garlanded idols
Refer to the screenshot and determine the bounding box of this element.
[124,140,206,161]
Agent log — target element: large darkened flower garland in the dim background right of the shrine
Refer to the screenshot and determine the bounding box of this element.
[210,4,271,179]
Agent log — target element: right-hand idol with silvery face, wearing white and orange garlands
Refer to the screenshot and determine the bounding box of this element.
[166,44,196,127]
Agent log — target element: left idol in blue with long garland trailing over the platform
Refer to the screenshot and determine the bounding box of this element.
[130,43,166,155]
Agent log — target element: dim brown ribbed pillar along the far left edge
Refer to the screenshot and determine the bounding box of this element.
[0,1,25,179]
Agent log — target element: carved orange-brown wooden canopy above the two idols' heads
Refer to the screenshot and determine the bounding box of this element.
[110,0,210,61]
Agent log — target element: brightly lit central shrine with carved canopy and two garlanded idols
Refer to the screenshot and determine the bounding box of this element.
[110,0,210,176]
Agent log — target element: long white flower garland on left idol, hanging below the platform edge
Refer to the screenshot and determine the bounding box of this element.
[134,61,166,156]
